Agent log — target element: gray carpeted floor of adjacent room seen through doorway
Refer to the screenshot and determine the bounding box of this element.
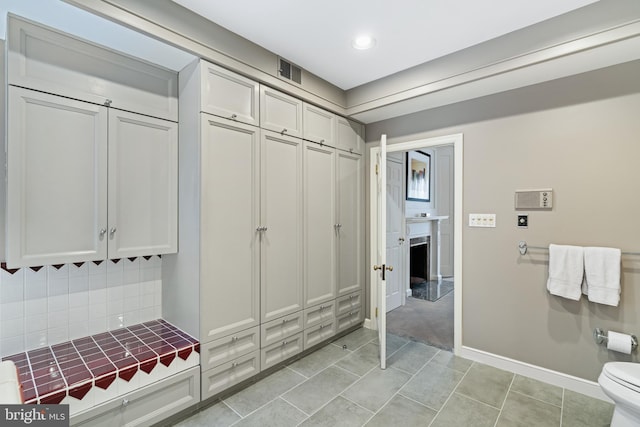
[387,284,453,350]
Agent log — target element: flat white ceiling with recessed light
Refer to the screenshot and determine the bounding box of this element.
[173,0,597,90]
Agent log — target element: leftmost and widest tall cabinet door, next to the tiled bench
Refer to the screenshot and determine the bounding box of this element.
[200,114,260,342]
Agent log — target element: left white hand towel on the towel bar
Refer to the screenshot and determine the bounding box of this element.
[547,244,584,301]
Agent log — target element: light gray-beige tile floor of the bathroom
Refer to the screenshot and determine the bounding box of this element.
[172,329,613,427]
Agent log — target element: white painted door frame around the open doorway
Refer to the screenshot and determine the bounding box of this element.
[368,134,463,354]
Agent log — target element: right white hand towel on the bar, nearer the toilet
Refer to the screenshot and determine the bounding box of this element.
[583,247,621,306]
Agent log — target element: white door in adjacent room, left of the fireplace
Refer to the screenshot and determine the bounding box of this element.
[386,158,404,312]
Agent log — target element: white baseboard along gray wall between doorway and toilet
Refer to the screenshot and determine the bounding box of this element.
[460,346,613,403]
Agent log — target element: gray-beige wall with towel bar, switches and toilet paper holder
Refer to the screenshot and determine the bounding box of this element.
[366,61,640,380]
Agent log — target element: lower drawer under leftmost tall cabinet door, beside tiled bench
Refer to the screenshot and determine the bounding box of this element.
[202,351,260,400]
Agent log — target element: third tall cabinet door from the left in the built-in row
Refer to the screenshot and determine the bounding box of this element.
[304,142,336,308]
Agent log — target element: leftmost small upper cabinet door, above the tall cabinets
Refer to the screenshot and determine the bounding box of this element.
[199,61,260,126]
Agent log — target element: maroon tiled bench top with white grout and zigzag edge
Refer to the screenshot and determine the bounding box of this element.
[2,319,200,404]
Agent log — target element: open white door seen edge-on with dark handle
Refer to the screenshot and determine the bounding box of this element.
[373,135,392,369]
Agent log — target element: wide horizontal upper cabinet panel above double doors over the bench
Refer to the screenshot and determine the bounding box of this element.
[7,15,178,121]
